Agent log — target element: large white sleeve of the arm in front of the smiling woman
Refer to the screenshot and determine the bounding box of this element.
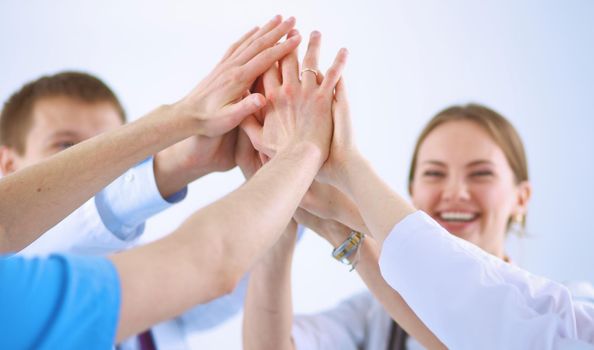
[380,211,594,349]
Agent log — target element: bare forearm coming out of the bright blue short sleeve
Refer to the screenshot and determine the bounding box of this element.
[112,141,321,339]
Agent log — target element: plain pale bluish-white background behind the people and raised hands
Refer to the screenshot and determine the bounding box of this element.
[0,0,594,349]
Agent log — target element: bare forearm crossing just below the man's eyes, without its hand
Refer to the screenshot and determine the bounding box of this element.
[0,107,194,252]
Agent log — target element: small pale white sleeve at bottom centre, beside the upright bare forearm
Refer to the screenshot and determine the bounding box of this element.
[292,293,372,350]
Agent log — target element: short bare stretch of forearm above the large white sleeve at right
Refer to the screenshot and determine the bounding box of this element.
[337,154,415,246]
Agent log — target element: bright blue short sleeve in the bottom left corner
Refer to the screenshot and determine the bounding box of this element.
[0,255,120,349]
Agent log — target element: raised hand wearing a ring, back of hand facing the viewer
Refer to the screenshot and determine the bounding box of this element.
[242,31,347,167]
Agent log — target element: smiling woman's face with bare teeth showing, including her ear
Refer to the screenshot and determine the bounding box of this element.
[410,119,530,258]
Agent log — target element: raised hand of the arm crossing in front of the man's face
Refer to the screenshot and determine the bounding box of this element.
[173,16,301,137]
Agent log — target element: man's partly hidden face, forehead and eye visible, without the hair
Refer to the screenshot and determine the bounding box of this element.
[1,96,122,175]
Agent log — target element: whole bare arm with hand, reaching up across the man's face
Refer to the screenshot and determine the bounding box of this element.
[0,17,300,252]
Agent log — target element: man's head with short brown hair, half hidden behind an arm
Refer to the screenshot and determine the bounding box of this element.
[0,72,126,175]
